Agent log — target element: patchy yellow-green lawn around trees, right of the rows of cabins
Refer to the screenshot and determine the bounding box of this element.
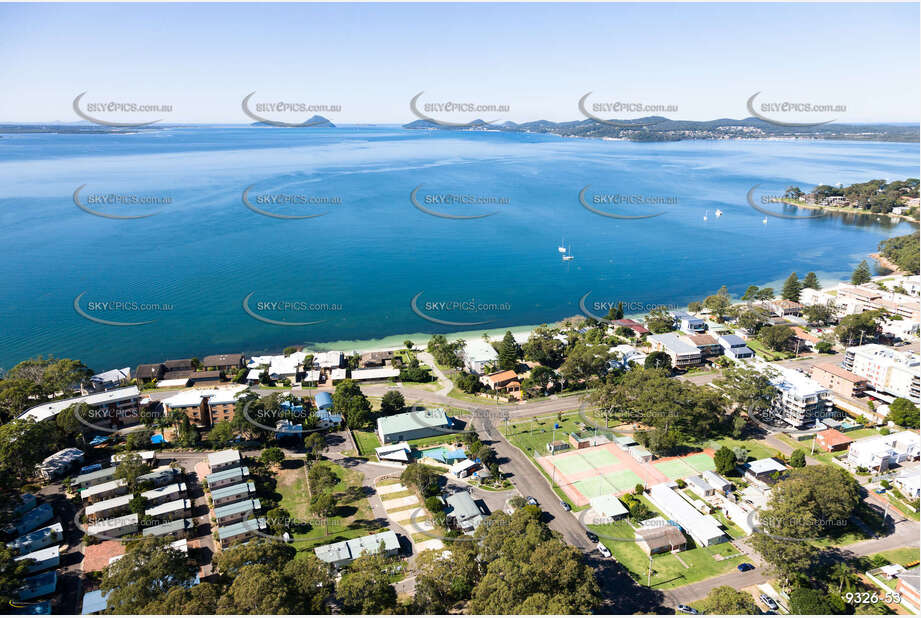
[275,462,379,552]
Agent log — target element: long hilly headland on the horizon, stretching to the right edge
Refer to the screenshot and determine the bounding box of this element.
[403,116,919,143]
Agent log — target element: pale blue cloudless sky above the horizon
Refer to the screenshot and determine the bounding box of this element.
[0,3,921,124]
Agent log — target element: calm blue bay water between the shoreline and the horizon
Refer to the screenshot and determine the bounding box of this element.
[0,122,919,370]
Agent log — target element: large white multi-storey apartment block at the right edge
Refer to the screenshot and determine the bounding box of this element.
[842,343,921,404]
